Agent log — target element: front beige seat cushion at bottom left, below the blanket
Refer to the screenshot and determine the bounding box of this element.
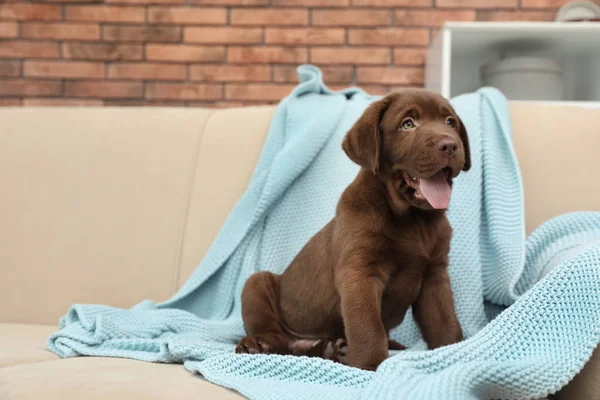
[0,357,241,400]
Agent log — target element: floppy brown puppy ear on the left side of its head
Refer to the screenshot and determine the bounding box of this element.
[342,94,395,174]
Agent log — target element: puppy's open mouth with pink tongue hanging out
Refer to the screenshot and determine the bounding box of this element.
[402,167,452,209]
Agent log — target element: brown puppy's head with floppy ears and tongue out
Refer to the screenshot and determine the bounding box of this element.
[342,89,471,209]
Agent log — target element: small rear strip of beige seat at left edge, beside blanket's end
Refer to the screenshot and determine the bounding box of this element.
[0,324,59,368]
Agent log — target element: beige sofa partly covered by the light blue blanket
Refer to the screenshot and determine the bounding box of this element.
[0,103,600,400]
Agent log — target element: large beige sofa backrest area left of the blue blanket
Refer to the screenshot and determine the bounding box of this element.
[0,107,274,323]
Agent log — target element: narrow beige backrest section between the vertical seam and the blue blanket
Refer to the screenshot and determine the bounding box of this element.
[179,106,275,286]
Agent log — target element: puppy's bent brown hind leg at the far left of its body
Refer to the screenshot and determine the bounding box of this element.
[235,271,291,354]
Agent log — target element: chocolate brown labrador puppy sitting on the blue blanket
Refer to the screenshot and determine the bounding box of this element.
[236,90,471,370]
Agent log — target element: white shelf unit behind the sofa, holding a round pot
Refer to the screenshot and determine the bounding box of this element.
[425,22,600,103]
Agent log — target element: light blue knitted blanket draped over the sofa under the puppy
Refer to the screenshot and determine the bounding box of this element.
[48,66,600,400]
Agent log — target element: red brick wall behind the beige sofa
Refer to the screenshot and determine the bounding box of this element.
[0,0,600,106]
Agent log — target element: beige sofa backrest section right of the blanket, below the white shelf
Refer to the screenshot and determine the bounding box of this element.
[510,102,600,238]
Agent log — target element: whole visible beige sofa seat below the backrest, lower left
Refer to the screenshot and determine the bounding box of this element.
[0,323,241,400]
